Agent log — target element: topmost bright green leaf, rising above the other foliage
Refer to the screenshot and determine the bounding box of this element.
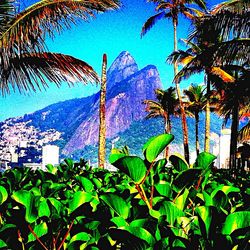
[143,134,174,162]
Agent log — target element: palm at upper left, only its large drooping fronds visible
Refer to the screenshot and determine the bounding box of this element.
[0,0,119,94]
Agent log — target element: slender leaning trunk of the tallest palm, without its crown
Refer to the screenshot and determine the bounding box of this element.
[173,19,189,163]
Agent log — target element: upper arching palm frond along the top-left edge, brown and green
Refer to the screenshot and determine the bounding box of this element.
[0,0,119,51]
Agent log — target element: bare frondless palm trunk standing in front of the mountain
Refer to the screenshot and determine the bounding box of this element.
[98,54,107,168]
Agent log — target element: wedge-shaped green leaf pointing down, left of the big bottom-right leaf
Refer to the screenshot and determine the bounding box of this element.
[195,206,213,237]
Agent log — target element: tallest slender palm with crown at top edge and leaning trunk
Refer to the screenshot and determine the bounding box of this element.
[141,0,206,162]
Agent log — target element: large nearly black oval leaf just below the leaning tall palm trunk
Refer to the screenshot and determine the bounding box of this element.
[173,168,202,192]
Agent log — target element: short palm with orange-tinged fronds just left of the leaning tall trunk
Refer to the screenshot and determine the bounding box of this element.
[143,87,178,158]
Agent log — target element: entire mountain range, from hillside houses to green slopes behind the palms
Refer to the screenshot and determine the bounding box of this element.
[0,51,225,164]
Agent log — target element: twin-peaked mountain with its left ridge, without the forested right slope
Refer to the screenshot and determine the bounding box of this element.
[0,51,162,158]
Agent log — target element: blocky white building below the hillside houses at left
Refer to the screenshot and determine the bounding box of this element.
[42,145,59,169]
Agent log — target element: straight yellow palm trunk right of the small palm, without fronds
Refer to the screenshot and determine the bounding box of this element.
[204,74,211,152]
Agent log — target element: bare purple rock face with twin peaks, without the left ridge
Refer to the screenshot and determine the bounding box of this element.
[63,52,162,154]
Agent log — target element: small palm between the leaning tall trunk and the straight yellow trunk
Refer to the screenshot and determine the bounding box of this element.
[184,84,207,156]
